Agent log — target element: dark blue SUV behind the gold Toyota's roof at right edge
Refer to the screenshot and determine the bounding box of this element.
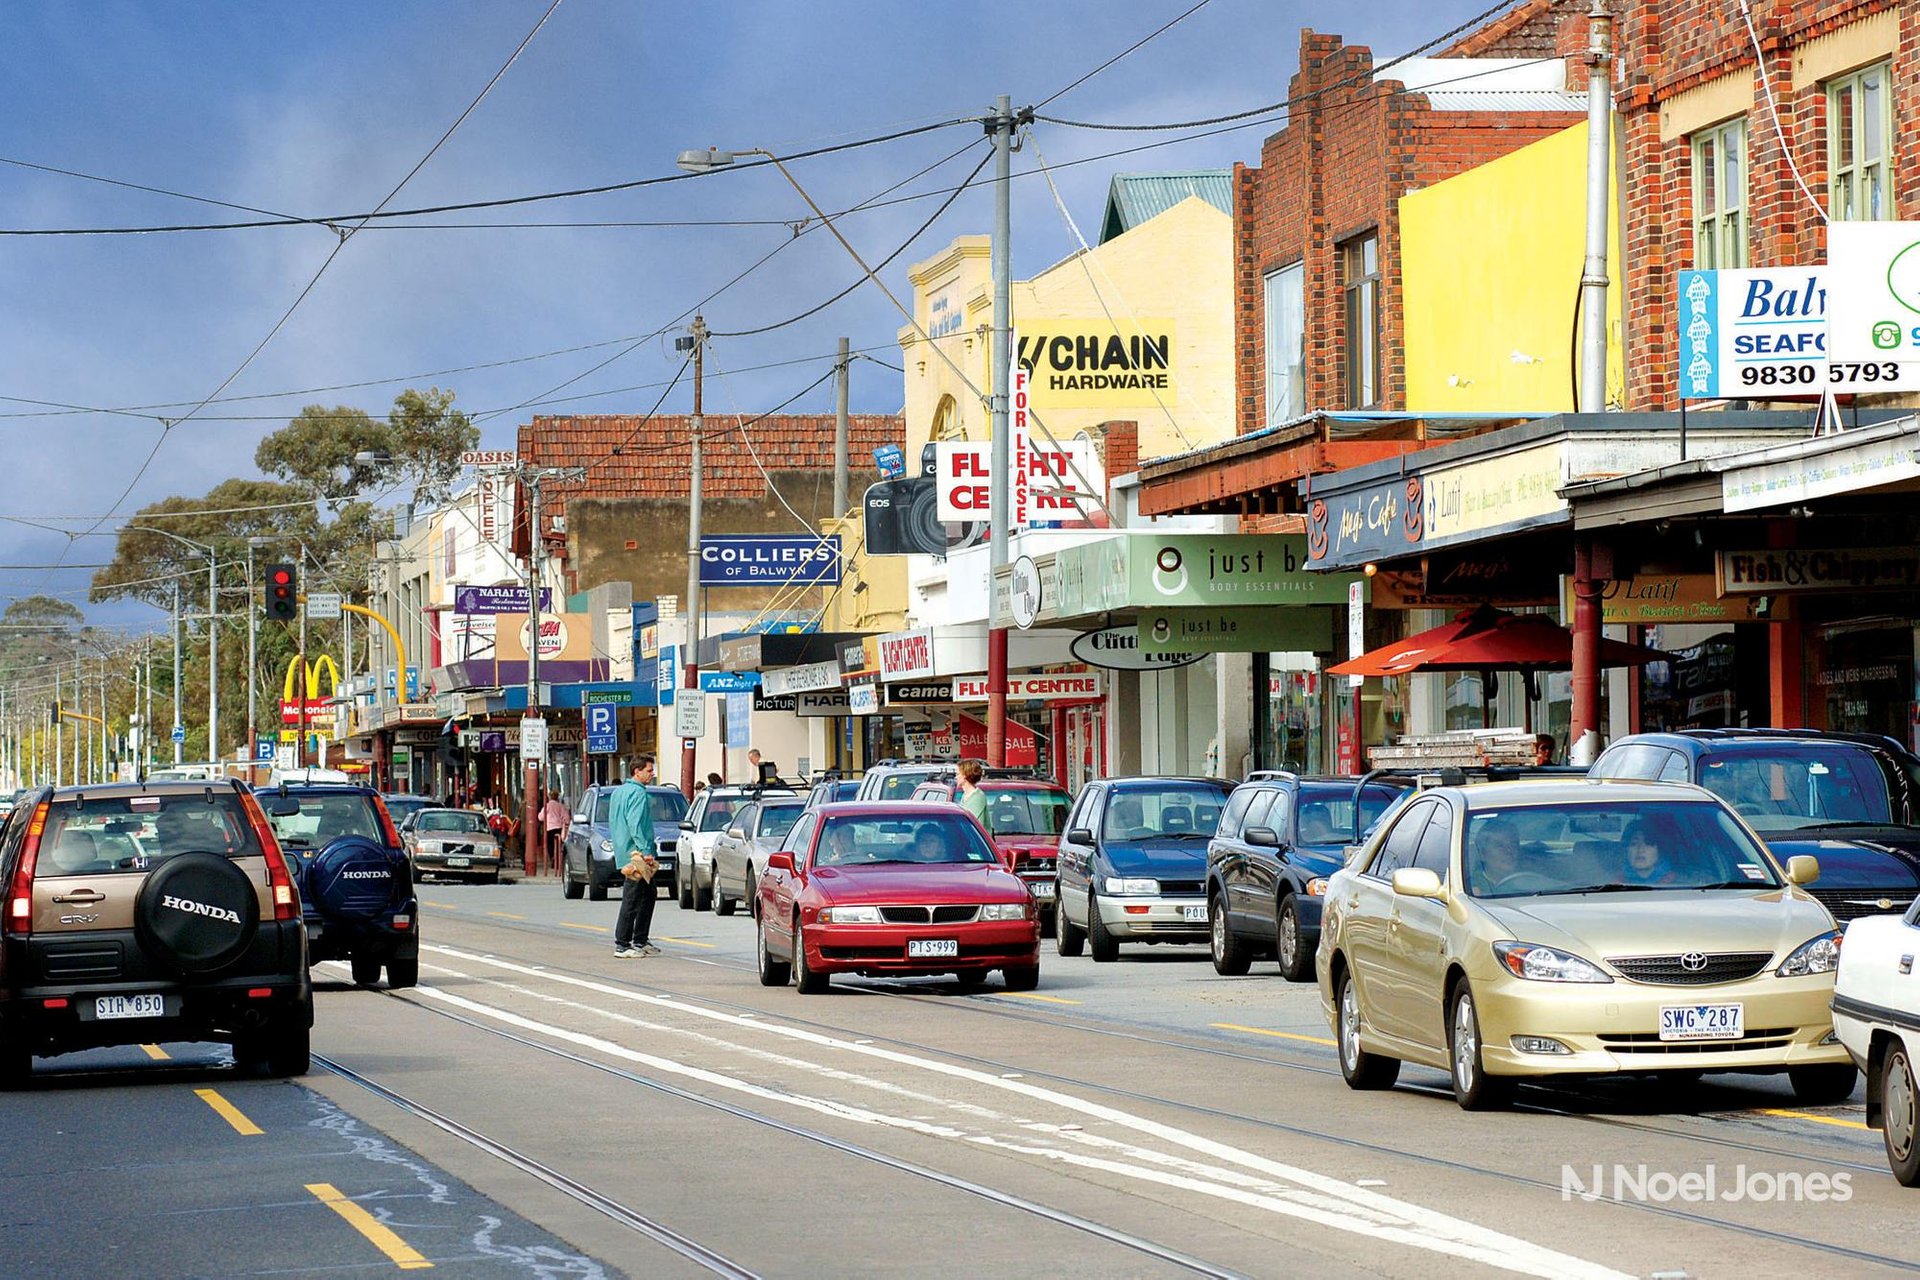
[1588,729,1920,923]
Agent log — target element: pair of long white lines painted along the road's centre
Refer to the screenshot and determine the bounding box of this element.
[428,946,1626,1280]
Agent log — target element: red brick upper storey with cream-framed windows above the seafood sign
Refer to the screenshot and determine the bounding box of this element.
[1612,0,1920,409]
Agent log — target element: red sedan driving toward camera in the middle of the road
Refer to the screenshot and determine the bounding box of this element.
[755,800,1041,994]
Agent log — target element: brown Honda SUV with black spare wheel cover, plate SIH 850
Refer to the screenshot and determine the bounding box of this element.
[0,781,313,1086]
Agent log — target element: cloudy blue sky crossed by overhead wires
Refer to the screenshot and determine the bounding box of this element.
[0,0,1512,626]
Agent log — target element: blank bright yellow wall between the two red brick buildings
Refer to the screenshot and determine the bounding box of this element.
[1400,123,1624,413]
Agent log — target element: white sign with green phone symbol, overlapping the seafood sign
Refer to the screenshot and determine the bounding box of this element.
[1826,223,1920,393]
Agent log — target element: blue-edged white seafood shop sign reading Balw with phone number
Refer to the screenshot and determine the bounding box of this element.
[1674,267,1826,399]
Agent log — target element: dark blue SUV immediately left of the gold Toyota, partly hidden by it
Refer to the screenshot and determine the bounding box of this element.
[1206,773,1407,983]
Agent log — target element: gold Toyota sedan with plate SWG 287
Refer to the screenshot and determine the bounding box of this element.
[1319,779,1855,1111]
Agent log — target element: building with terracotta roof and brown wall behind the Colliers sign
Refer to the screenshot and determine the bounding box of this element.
[513,415,906,608]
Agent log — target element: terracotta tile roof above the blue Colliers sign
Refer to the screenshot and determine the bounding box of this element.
[515,413,906,551]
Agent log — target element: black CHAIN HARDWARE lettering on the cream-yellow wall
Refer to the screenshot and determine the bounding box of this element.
[1018,317,1177,411]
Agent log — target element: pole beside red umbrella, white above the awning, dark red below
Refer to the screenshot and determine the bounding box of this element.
[1567,0,1613,764]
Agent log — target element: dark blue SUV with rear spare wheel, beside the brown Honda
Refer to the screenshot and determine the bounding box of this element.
[257,783,420,986]
